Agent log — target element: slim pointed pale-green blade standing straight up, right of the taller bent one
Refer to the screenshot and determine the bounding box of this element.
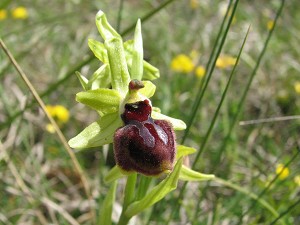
[131,19,144,80]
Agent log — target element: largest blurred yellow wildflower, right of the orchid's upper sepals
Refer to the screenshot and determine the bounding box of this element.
[171,54,195,73]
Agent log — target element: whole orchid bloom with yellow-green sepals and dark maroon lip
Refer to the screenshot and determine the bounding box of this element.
[69,11,214,217]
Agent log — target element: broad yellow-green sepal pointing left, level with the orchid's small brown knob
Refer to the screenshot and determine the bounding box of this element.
[76,88,121,116]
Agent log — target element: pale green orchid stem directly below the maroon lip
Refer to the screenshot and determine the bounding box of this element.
[118,173,137,225]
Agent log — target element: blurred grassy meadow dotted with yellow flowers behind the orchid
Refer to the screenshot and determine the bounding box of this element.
[0,0,300,225]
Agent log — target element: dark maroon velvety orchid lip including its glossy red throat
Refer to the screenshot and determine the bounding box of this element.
[114,99,176,176]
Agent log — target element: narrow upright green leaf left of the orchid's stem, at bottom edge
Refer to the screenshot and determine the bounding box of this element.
[99,181,117,225]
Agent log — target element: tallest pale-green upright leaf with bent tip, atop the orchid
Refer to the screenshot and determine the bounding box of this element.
[96,10,130,96]
